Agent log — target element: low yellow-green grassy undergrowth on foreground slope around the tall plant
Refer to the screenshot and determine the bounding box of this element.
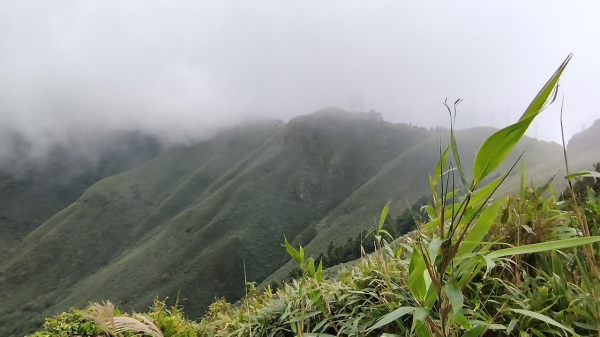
[33,154,600,337]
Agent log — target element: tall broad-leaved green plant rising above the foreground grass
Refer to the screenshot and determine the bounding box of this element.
[371,55,600,337]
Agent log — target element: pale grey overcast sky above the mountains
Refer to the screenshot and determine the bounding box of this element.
[0,0,600,146]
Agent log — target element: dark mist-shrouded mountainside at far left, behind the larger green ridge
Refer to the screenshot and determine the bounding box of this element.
[0,131,163,259]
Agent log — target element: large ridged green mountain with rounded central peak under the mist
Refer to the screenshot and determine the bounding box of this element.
[0,108,594,335]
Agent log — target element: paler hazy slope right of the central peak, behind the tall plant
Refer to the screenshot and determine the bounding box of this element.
[263,127,568,285]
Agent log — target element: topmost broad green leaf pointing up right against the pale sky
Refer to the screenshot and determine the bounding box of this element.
[471,55,572,190]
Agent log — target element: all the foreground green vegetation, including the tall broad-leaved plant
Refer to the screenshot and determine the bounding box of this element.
[33,56,600,337]
